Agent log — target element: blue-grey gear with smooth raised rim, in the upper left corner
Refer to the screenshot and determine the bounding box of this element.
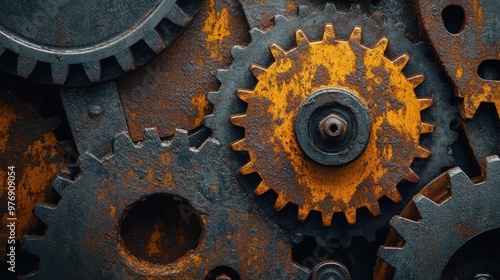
[0,0,203,86]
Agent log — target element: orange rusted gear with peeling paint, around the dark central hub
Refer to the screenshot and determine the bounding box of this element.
[231,25,434,226]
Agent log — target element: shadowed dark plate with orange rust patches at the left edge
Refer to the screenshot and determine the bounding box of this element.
[0,82,68,261]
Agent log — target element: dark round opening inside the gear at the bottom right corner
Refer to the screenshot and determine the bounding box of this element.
[441,228,500,280]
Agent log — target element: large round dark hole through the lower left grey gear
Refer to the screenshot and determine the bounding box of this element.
[119,194,202,264]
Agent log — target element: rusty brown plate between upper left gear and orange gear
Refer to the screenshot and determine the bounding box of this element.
[117,0,248,141]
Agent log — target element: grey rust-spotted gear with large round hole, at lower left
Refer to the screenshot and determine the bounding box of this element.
[25,129,308,279]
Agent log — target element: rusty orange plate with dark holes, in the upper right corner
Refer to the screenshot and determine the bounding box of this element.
[415,0,500,119]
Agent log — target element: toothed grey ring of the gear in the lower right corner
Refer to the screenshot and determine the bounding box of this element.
[377,156,500,279]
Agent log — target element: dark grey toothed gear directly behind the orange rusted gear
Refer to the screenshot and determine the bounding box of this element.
[206,2,458,246]
